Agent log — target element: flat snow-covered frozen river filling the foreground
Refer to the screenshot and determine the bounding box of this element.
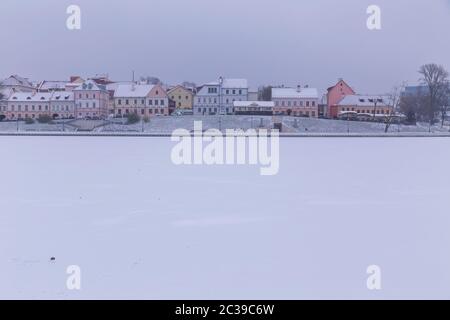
[0,137,450,299]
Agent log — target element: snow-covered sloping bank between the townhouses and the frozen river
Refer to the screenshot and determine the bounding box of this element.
[0,116,450,134]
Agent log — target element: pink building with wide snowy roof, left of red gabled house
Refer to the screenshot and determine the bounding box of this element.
[272,86,319,118]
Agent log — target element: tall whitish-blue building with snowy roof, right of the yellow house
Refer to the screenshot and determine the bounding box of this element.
[194,78,248,115]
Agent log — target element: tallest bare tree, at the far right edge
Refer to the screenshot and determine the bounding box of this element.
[419,63,449,131]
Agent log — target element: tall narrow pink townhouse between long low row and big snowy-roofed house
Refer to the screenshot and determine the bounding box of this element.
[73,80,109,119]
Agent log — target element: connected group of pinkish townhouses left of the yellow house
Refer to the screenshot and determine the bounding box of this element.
[0,80,169,120]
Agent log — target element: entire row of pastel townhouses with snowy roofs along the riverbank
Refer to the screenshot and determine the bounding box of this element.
[0,76,400,120]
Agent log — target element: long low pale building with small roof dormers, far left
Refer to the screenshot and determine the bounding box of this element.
[5,92,52,120]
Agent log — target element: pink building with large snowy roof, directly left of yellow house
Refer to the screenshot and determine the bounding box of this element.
[114,84,169,117]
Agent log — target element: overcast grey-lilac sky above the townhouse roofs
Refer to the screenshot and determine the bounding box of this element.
[0,0,450,93]
